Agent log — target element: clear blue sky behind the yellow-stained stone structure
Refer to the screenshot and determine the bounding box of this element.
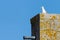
[0,0,60,40]
